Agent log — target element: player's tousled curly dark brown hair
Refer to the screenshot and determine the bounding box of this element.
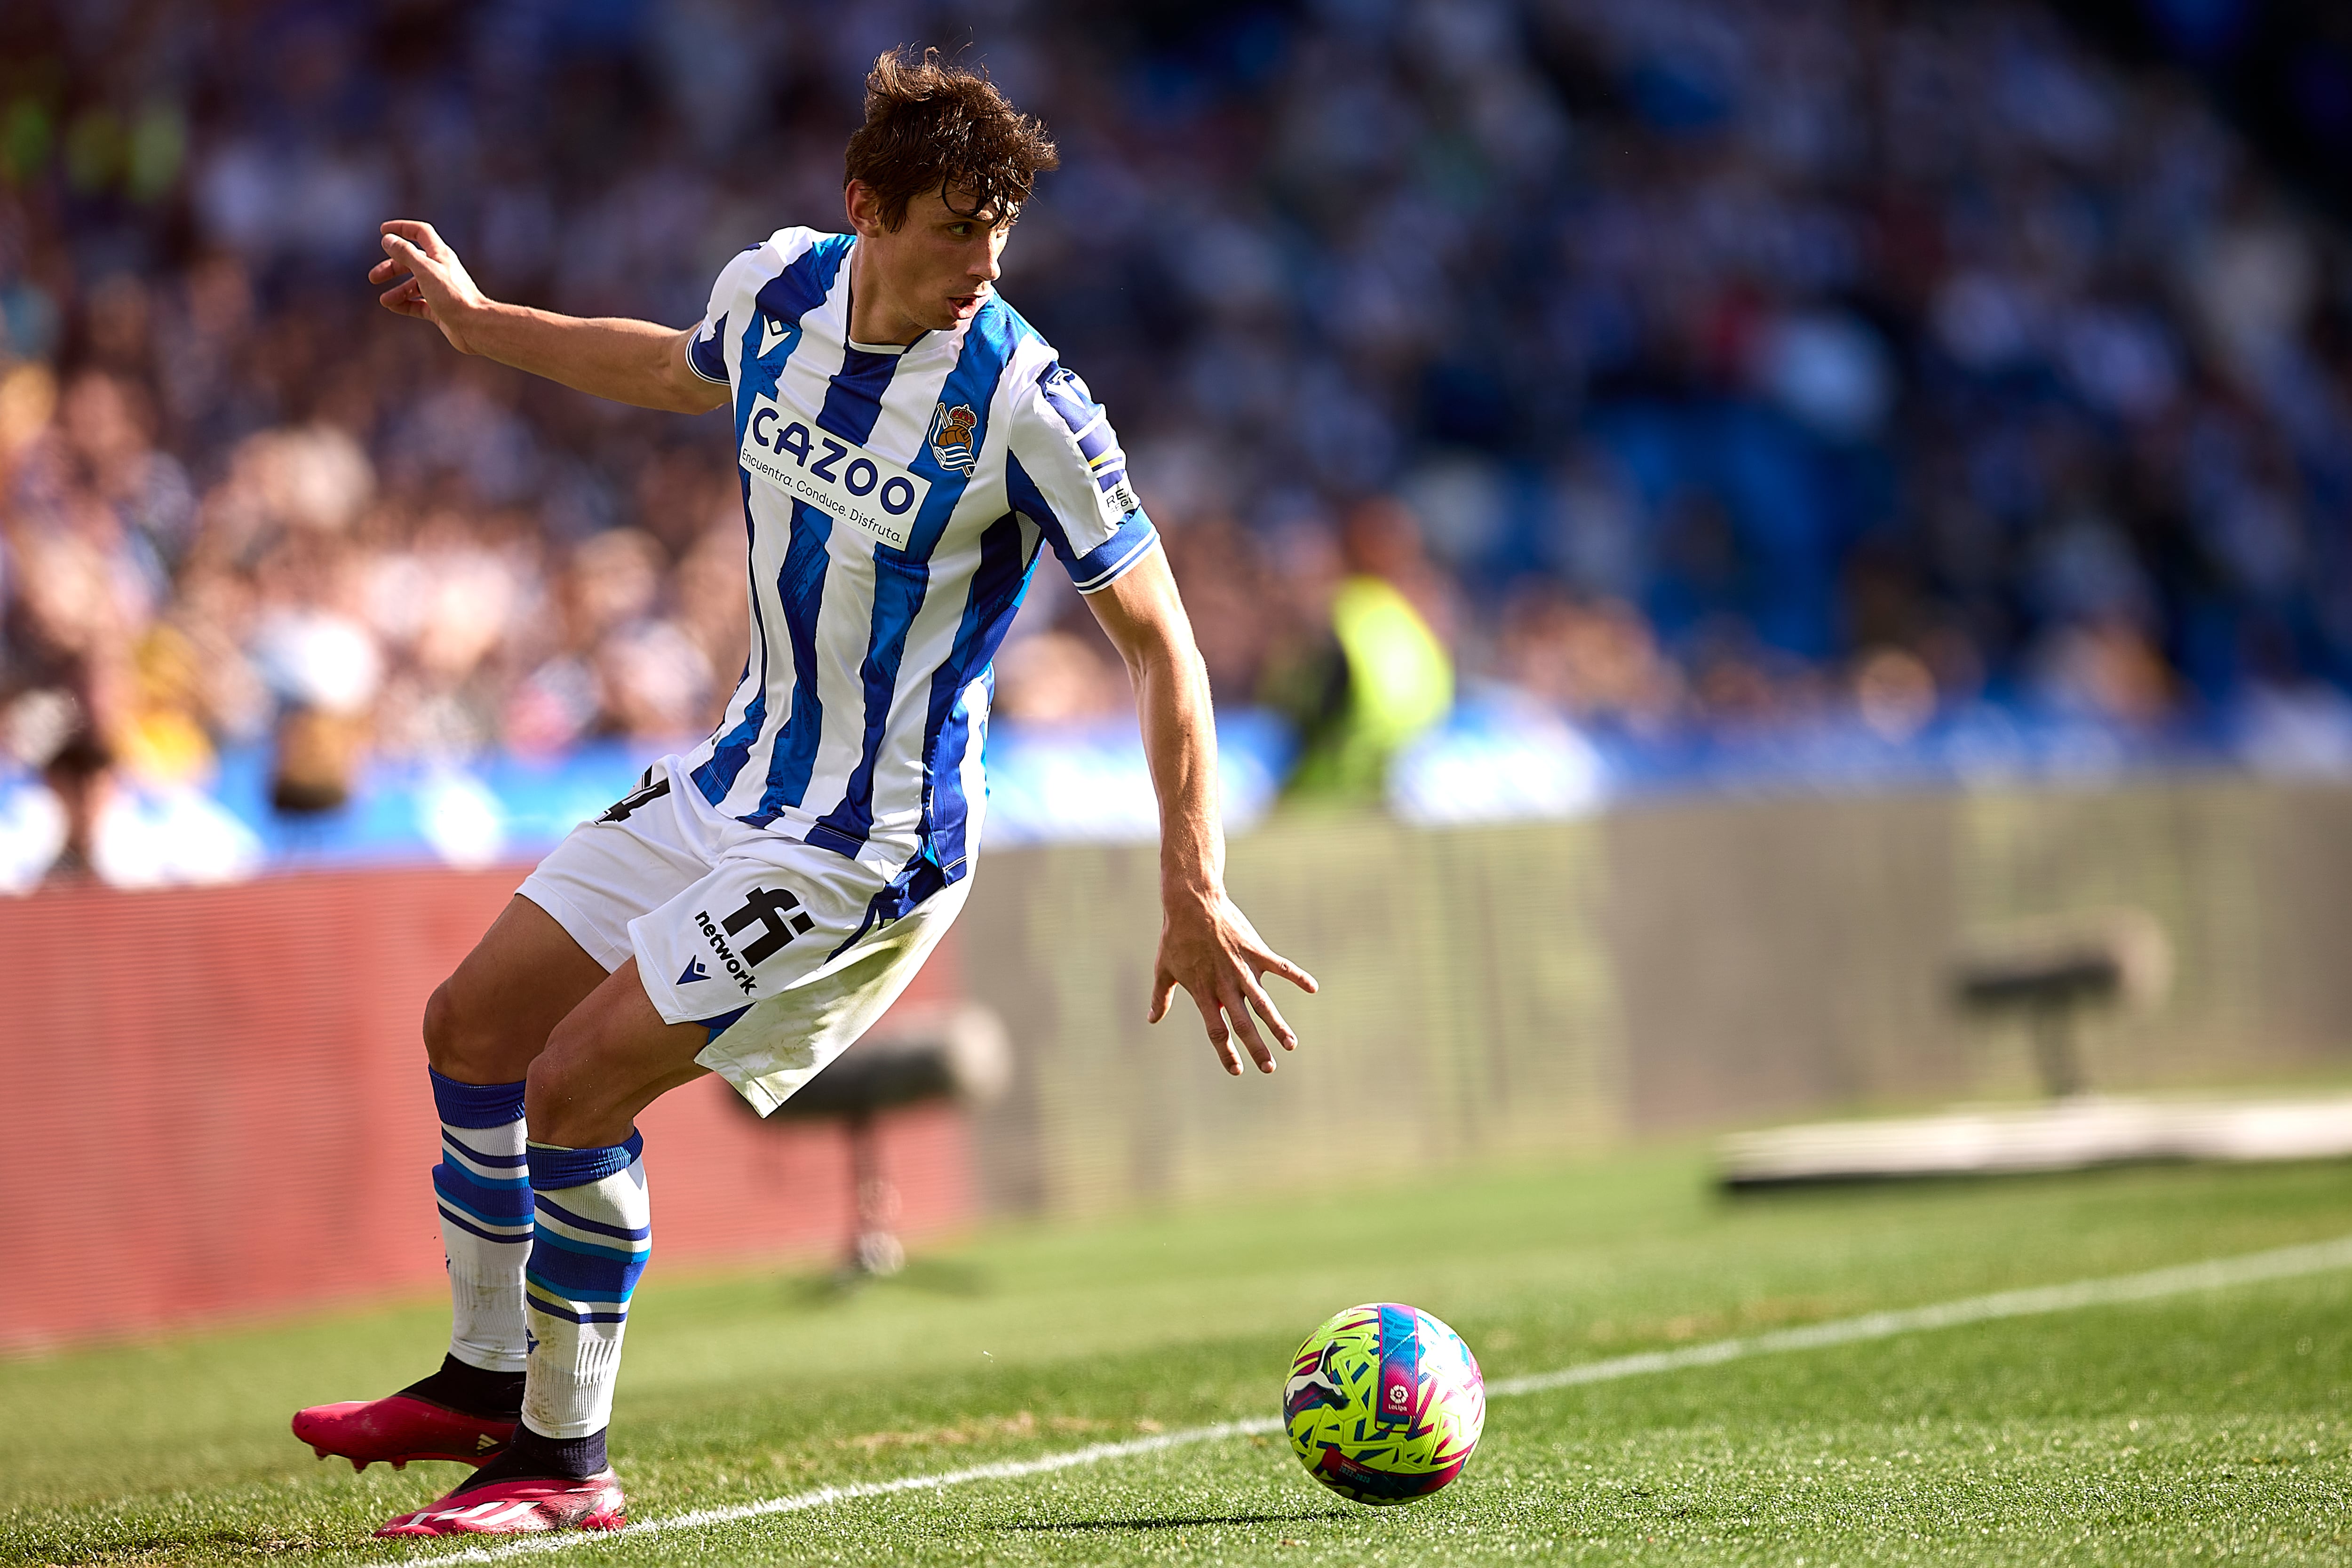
[842,47,1061,228]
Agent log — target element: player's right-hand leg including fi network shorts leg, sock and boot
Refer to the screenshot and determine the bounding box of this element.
[383,839,969,1535]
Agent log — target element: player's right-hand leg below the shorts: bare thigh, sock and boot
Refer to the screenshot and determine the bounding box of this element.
[381,959,710,1535]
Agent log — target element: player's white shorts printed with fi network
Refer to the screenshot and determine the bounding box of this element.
[515,757,971,1117]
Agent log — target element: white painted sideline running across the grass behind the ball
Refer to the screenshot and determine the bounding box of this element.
[372,1236,2352,1568]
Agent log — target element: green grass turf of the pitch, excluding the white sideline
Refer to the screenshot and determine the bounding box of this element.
[0,1154,2352,1568]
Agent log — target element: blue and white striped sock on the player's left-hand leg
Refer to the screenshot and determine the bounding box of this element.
[428,1070,532,1373]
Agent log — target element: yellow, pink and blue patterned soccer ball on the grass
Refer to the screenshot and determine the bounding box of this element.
[1282,1302,1486,1504]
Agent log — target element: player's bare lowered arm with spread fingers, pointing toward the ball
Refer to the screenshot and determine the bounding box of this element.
[1087,550,1315,1075]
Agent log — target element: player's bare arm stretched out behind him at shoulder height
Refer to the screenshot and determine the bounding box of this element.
[367,219,727,414]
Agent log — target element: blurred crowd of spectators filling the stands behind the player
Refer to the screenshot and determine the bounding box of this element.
[0,0,2352,883]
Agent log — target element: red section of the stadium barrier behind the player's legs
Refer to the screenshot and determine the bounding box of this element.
[0,870,971,1352]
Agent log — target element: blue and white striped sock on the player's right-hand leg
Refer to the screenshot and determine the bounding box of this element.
[522,1131,654,1439]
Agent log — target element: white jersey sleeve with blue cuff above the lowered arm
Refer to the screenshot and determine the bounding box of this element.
[1004,362,1160,592]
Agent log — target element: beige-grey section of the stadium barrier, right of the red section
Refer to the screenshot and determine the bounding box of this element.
[962,778,2352,1213]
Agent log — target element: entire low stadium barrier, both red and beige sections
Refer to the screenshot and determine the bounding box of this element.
[18,780,2352,1349]
